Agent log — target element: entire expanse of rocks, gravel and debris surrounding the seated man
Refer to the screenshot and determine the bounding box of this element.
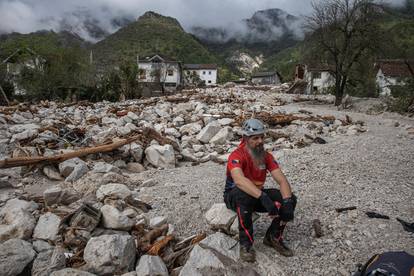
[0,84,414,276]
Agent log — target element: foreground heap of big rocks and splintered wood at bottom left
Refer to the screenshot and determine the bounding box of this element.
[0,175,257,276]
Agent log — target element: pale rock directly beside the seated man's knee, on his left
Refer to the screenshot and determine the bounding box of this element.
[205,203,237,231]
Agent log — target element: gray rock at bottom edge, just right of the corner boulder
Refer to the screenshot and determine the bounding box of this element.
[32,247,66,276]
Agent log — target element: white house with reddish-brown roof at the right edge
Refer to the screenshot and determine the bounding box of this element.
[374,59,414,96]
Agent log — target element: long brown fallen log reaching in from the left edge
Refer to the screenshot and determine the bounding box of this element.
[0,135,142,169]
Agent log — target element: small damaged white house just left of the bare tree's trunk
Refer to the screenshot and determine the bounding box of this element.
[304,66,335,94]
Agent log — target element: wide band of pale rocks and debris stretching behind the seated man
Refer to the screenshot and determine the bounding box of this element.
[0,86,366,182]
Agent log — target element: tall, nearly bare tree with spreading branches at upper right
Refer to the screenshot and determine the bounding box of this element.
[307,0,381,106]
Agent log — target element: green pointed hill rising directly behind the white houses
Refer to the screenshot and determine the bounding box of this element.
[92,12,216,66]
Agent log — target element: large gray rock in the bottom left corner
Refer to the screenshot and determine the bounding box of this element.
[0,239,36,276]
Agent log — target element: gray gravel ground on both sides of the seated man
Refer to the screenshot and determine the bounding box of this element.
[134,101,414,275]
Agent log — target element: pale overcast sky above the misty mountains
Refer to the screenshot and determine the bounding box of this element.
[0,0,404,37]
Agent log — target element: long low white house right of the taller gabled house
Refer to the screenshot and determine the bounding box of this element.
[184,64,217,86]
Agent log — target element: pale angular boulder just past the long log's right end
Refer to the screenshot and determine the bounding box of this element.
[145,145,175,168]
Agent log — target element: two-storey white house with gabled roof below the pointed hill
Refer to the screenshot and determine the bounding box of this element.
[137,55,182,89]
